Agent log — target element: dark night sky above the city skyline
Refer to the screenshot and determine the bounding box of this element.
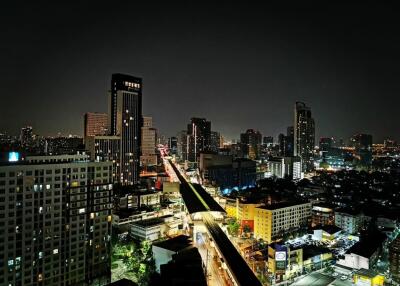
[0,1,400,142]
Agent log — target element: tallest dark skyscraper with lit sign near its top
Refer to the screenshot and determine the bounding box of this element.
[109,74,143,185]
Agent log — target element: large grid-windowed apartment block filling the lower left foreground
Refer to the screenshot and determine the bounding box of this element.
[0,155,112,285]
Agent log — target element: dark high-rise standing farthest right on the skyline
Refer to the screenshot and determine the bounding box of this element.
[351,134,372,167]
